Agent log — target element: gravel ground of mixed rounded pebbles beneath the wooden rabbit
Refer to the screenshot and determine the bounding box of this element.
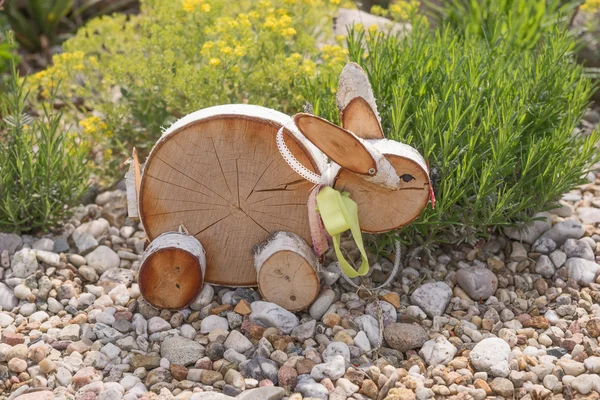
[0,119,600,400]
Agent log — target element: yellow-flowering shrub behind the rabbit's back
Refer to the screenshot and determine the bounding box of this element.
[31,0,346,180]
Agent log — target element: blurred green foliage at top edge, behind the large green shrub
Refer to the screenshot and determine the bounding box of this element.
[429,0,581,49]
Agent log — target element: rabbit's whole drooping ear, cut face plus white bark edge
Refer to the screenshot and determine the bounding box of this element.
[294,114,400,189]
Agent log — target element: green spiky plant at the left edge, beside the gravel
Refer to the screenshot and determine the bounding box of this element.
[0,39,87,232]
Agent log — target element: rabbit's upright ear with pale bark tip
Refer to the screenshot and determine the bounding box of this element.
[336,62,384,139]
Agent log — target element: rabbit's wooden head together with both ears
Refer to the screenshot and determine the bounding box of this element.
[294,63,431,232]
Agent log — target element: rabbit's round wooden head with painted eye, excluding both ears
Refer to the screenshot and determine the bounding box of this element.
[332,139,430,233]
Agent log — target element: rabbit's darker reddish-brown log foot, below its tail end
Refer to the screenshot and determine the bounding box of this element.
[138,232,206,309]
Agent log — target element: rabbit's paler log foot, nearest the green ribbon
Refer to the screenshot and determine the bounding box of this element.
[254,232,319,311]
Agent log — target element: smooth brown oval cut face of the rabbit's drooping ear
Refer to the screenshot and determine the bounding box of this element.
[294,113,377,175]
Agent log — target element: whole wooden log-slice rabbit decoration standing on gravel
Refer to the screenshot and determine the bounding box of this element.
[127,63,430,310]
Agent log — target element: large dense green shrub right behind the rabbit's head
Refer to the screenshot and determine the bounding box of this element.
[305,24,600,247]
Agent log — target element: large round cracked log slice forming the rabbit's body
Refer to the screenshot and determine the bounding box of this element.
[139,105,325,286]
